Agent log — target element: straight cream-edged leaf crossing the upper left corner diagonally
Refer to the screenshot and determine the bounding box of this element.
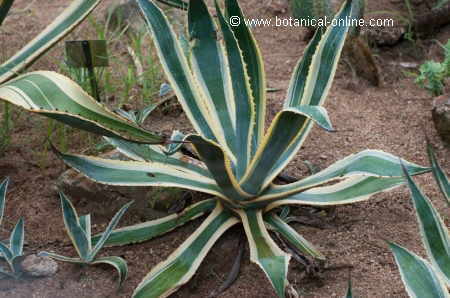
[0,0,100,82]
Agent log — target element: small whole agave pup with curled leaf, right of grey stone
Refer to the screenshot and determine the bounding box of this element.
[39,193,133,286]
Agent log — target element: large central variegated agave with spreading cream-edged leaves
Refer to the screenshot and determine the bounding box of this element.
[0,0,428,297]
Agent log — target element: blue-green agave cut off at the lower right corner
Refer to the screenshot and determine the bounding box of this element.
[389,144,450,298]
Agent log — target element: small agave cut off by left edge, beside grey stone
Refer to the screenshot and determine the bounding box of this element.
[0,178,25,278]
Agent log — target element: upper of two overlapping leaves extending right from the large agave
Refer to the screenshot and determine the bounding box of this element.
[258,150,429,200]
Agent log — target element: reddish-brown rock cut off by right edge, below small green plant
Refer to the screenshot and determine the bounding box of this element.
[431,94,450,145]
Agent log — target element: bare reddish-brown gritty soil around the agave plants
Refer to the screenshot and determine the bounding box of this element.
[0,0,450,298]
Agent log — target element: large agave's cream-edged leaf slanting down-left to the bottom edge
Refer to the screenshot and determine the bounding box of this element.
[133,203,239,298]
